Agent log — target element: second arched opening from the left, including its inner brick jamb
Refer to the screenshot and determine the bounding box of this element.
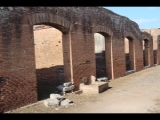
[94,32,113,79]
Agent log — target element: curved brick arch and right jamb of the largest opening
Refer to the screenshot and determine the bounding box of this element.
[28,13,73,82]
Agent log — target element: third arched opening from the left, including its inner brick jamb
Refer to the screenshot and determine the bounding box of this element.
[124,36,135,73]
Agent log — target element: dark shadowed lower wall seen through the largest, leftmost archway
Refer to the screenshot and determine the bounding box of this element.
[36,65,64,100]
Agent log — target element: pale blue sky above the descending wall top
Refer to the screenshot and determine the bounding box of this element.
[103,6,160,29]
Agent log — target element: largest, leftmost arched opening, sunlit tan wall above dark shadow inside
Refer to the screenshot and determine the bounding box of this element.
[33,25,64,100]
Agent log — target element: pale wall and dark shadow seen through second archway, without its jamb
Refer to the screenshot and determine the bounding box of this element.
[94,33,106,78]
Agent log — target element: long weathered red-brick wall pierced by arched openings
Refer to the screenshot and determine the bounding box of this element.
[0,7,160,112]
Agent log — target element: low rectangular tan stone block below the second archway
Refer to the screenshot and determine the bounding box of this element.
[80,82,108,94]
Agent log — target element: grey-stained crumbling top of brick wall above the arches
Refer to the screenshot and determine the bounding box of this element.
[0,7,140,37]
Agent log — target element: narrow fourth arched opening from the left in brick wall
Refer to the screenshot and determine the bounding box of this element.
[143,39,150,68]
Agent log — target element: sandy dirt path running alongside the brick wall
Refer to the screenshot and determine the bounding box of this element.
[6,66,160,113]
